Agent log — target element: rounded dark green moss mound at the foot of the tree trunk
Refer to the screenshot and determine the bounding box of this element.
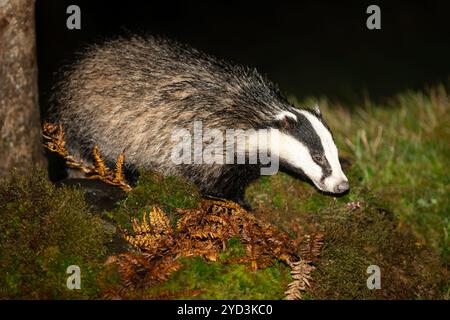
[0,172,110,299]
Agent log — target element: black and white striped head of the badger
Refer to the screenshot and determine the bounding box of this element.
[275,108,349,193]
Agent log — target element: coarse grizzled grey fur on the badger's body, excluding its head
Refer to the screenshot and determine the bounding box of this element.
[52,37,296,199]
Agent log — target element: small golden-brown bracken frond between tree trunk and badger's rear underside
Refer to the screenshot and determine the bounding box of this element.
[43,122,131,192]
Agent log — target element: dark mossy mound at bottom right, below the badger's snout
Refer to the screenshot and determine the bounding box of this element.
[313,202,446,299]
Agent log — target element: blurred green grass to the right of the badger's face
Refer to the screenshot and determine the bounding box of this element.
[310,86,450,263]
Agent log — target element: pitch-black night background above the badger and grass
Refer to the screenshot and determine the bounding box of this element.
[36,0,450,117]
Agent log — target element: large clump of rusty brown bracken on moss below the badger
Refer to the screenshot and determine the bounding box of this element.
[107,199,321,299]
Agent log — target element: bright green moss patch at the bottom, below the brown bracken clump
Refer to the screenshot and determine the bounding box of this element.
[142,239,291,299]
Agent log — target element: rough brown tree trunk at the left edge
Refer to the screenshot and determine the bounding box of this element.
[0,0,46,178]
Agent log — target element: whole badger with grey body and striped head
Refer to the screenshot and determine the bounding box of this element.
[51,36,349,203]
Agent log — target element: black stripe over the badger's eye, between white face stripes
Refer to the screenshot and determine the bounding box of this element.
[277,112,332,182]
